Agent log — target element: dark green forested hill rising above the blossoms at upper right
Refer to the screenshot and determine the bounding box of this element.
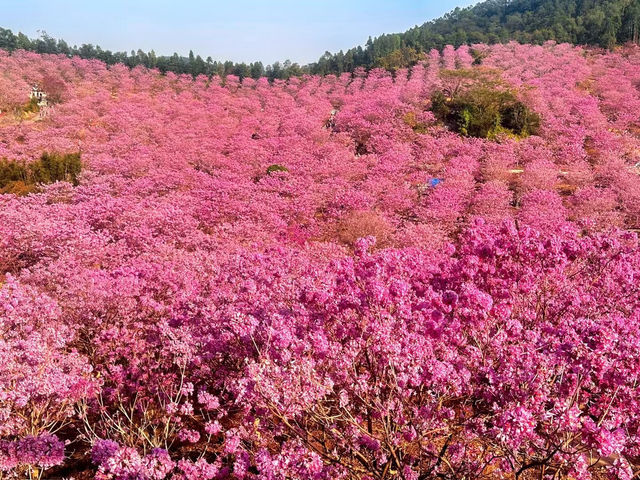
[311,0,640,74]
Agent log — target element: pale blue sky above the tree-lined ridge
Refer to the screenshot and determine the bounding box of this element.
[0,0,476,64]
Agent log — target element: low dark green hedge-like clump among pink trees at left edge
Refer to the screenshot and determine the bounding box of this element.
[0,152,82,194]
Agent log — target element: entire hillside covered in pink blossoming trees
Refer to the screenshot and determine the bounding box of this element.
[0,43,640,480]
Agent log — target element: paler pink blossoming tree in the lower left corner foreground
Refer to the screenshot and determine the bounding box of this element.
[0,276,98,478]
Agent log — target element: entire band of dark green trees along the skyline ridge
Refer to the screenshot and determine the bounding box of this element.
[0,0,640,80]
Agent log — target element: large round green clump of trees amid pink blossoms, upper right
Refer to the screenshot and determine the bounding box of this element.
[431,69,540,139]
